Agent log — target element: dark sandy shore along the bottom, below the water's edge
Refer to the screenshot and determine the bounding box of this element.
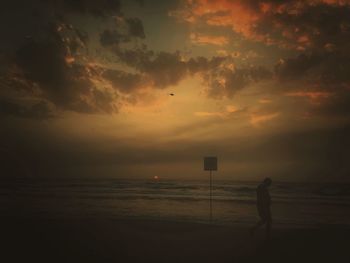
[1,219,350,262]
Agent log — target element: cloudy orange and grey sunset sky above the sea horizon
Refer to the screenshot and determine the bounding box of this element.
[0,0,350,182]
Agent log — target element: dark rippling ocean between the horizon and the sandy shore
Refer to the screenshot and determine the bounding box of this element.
[0,179,350,227]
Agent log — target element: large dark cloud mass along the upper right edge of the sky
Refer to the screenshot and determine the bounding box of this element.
[256,1,350,117]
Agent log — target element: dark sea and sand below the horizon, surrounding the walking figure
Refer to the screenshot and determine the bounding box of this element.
[0,179,350,263]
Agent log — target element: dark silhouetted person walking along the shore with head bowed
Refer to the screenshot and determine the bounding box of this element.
[251,178,272,239]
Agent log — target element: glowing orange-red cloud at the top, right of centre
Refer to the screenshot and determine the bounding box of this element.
[172,0,350,50]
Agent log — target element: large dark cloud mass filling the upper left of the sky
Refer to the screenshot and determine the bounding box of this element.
[0,0,136,118]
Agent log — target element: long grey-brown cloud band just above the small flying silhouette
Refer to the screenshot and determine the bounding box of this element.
[110,43,272,93]
